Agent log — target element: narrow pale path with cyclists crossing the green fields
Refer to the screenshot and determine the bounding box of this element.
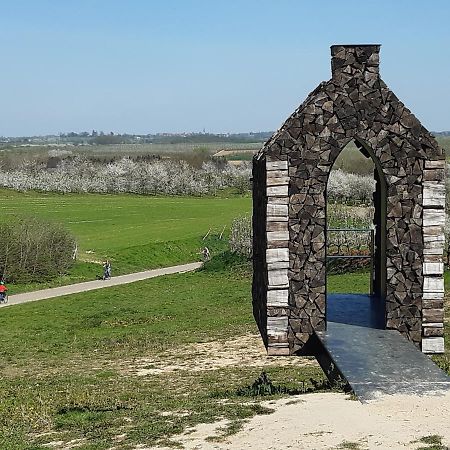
[0,262,202,308]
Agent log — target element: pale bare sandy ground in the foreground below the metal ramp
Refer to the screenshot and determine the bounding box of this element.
[154,393,450,450]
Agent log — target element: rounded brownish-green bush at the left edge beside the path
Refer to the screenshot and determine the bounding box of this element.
[0,217,76,282]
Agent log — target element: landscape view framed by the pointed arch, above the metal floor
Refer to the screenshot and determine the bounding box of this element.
[325,140,375,294]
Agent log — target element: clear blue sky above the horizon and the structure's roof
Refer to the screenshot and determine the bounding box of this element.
[0,0,450,136]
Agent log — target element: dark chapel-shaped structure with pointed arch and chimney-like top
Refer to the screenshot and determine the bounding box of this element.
[253,45,445,355]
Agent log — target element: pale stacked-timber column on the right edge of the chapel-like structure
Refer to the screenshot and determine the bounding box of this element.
[422,160,445,353]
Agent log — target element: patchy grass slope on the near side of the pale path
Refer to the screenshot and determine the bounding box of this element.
[0,260,323,450]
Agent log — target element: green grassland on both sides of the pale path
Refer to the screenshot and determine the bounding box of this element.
[0,135,450,450]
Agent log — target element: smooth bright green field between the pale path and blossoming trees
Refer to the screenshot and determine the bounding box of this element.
[0,190,251,293]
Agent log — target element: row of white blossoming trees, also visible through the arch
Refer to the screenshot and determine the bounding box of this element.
[0,156,373,204]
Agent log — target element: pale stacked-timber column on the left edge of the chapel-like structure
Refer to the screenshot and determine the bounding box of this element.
[266,159,289,356]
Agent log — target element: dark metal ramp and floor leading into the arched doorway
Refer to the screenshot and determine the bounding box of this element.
[316,294,450,401]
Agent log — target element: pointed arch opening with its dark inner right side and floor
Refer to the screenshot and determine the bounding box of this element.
[325,138,387,328]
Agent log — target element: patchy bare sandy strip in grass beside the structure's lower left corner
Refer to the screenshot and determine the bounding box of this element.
[125,334,317,376]
